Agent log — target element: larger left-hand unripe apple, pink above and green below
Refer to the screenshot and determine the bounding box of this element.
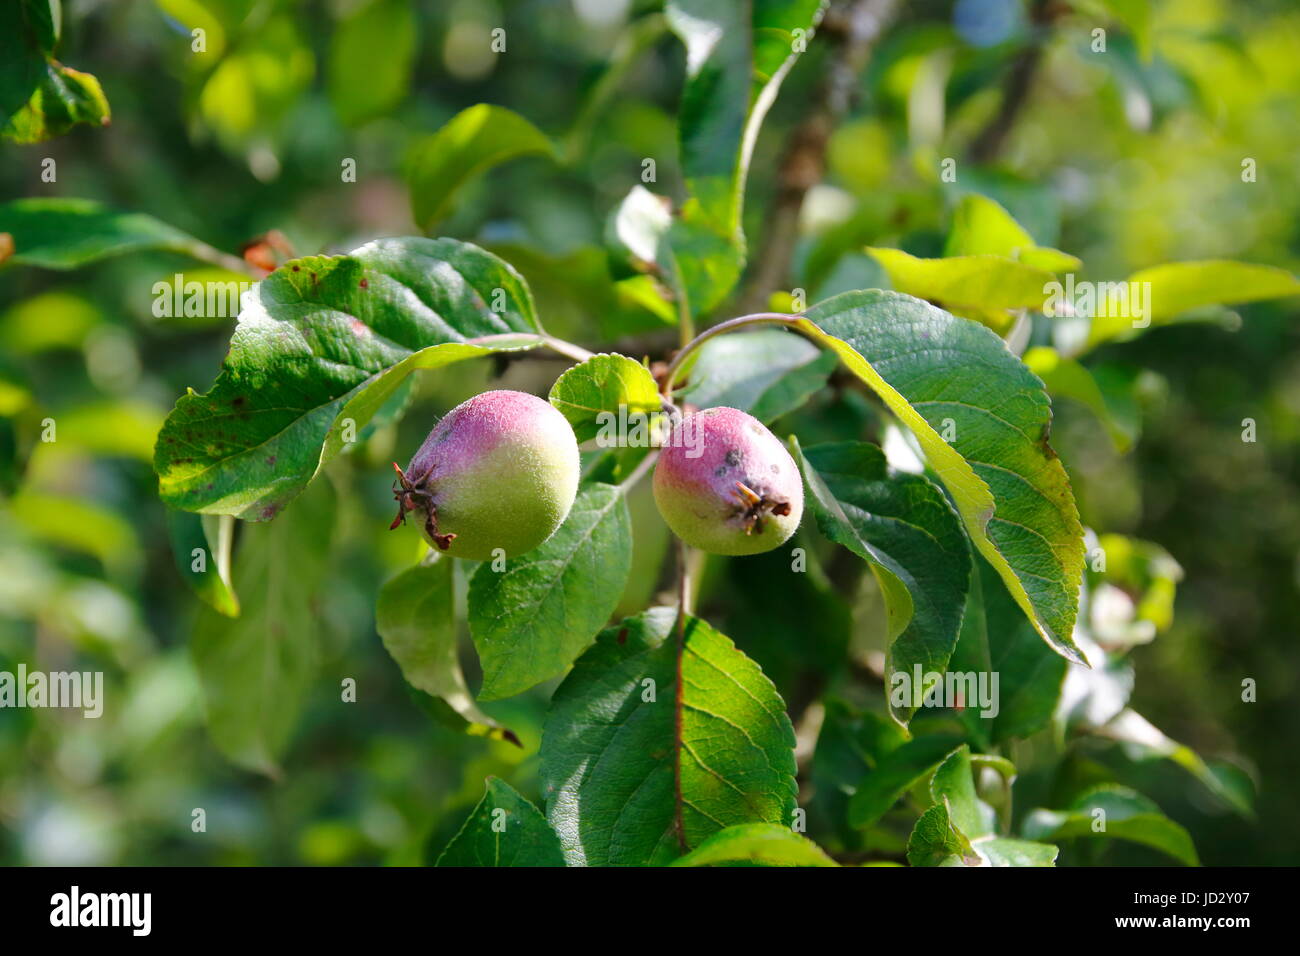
[393,390,580,561]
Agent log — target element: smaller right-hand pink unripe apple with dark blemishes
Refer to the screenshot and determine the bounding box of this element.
[654,407,803,554]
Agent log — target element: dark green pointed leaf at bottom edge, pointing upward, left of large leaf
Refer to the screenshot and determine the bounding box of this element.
[434,780,564,866]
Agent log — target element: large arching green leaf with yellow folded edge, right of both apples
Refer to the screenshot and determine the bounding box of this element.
[794,290,1083,662]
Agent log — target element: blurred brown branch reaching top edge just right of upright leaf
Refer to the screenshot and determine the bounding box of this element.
[736,0,898,312]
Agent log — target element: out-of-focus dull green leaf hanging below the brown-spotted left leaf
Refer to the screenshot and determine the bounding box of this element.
[190,481,334,775]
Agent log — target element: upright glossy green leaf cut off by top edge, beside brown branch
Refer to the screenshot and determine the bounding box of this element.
[664,0,822,235]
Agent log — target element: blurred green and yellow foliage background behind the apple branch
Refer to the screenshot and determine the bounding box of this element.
[0,0,1300,865]
